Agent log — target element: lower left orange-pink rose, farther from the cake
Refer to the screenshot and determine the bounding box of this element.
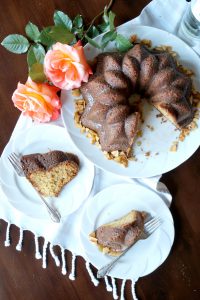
[12,77,61,122]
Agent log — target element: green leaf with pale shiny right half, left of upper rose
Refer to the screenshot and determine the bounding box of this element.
[27,44,45,68]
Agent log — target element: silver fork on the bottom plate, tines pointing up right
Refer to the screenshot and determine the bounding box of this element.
[97,217,161,278]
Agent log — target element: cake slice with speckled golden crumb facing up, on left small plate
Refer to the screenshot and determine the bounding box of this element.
[21,150,79,197]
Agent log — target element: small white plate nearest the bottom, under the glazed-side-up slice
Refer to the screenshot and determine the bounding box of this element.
[80,184,174,281]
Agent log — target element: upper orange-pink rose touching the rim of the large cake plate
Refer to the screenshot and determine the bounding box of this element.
[44,41,92,90]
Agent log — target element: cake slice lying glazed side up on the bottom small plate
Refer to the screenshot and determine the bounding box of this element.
[89,210,146,256]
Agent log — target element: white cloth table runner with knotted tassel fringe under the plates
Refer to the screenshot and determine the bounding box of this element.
[0,0,195,299]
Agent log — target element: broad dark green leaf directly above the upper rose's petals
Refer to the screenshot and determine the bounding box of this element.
[40,26,75,47]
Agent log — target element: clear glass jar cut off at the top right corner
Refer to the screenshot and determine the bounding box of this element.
[178,0,200,46]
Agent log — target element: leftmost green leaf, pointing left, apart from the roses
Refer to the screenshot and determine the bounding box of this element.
[1,34,30,54]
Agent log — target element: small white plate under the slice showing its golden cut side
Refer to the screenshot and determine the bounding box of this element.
[0,124,94,219]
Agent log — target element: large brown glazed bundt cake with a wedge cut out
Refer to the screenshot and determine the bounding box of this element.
[81,44,193,153]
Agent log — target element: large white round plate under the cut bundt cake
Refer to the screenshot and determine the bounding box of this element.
[62,25,200,178]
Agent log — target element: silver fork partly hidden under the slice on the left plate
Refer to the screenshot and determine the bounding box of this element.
[8,152,61,223]
